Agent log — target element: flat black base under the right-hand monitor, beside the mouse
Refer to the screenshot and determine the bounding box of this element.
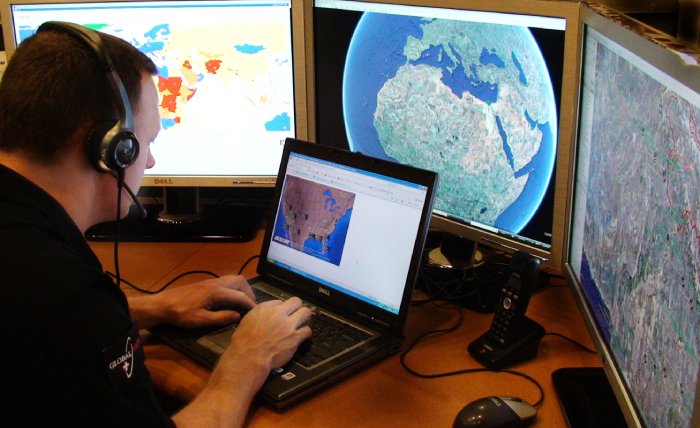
[552,367,627,428]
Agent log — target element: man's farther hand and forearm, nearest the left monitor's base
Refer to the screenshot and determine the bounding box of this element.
[129,275,255,328]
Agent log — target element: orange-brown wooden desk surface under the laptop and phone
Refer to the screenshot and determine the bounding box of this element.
[91,233,600,428]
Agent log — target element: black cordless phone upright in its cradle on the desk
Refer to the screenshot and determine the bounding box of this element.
[468,250,544,369]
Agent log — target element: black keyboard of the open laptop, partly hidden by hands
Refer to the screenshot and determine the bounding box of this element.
[198,288,372,368]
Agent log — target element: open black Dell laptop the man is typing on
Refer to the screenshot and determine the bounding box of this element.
[152,138,438,409]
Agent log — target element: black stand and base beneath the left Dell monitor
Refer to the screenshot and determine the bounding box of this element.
[85,187,265,242]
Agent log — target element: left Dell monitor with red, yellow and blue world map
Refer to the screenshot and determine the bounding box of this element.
[0,0,307,239]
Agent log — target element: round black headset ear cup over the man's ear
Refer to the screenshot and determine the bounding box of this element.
[87,121,139,173]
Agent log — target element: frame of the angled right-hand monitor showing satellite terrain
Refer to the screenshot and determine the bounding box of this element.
[563,6,700,427]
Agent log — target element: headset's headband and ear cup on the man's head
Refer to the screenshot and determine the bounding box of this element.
[37,21,140,175]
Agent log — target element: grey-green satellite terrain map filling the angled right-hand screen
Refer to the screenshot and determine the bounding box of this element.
[581,36,700,427]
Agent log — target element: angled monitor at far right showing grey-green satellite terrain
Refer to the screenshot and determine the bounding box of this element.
[563,4,700,427]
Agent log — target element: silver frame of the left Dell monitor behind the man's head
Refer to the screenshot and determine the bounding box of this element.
[0,0,308,188]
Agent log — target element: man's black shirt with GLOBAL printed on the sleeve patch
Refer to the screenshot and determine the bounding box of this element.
[0,165,172,427]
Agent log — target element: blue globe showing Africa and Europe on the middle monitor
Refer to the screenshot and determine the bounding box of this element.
[343,13,557,233]
